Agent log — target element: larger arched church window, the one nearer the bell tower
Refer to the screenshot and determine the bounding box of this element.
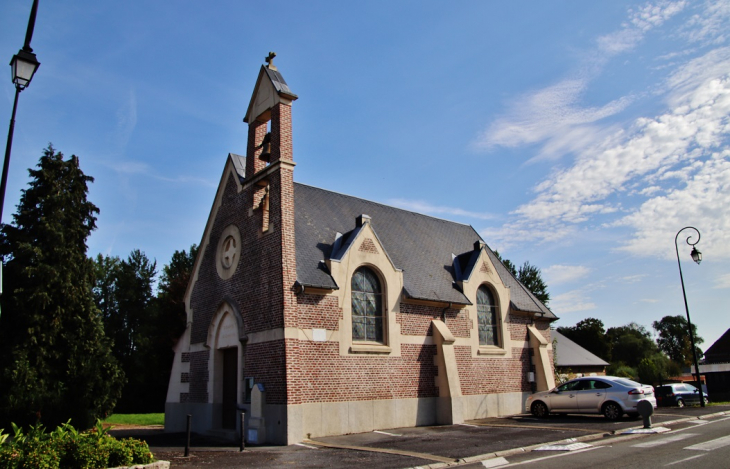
[352,267,383,343]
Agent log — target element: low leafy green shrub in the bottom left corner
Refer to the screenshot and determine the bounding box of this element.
[0,421,154,469]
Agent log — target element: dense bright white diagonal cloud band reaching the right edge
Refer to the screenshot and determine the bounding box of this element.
[516,61,730,229]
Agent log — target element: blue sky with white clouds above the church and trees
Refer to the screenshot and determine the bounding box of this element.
[0,0,730,348]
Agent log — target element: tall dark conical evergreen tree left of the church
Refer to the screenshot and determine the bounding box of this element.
[0,145,124,428]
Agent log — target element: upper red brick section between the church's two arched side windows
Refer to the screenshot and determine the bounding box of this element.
[396,303,472,337]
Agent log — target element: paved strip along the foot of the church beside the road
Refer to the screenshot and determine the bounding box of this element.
[112,406,730,469]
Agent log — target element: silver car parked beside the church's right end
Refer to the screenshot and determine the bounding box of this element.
[525,376,657,420]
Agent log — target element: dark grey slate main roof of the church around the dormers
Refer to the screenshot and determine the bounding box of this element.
[294,183,557,319]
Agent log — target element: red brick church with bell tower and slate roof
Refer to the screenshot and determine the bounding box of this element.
[165,56,557,444]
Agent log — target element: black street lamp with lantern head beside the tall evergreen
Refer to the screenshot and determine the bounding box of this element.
[0,0,40,222]
